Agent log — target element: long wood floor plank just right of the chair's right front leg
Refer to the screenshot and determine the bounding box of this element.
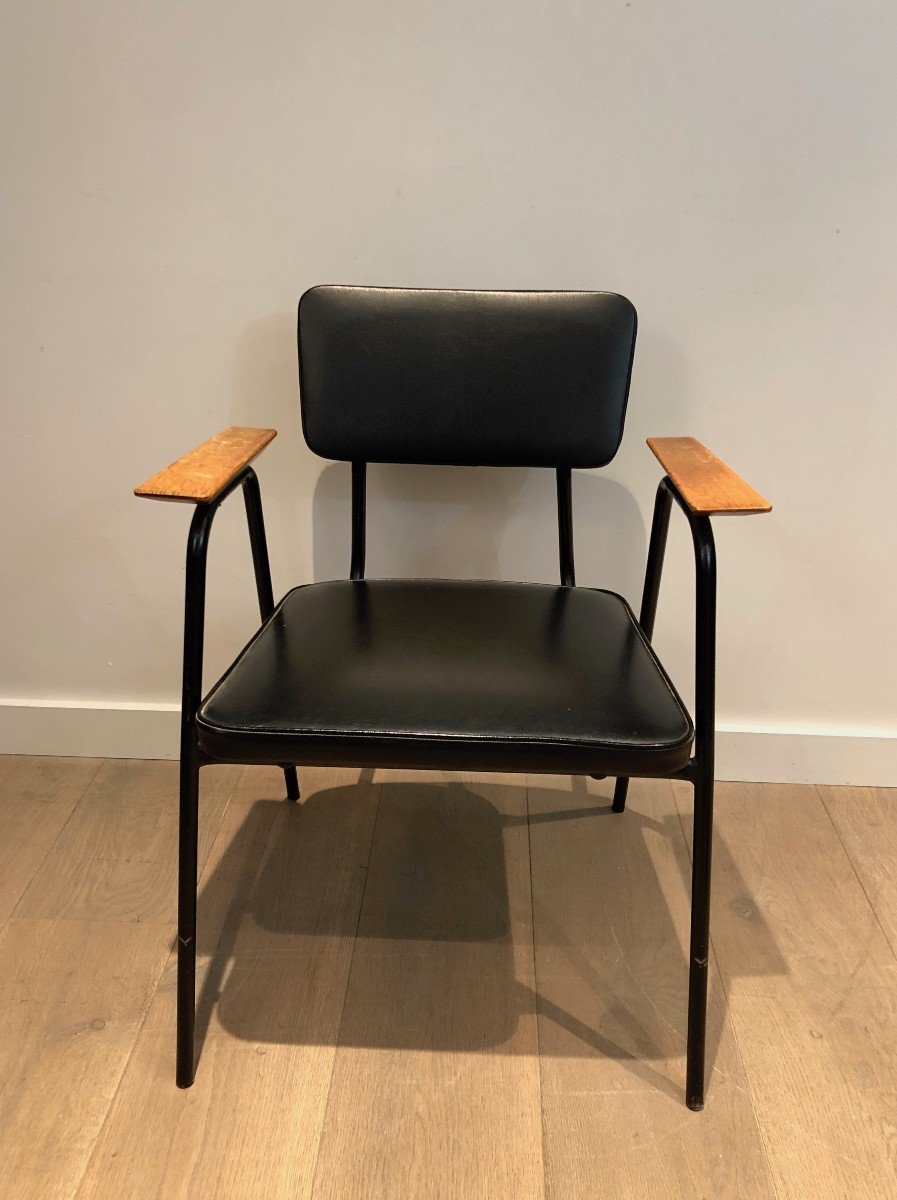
[676,784,897,1200]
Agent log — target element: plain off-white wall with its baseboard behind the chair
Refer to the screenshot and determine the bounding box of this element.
[0,0,897,782]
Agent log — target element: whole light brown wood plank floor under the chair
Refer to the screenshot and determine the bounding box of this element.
[0,757,897,1200]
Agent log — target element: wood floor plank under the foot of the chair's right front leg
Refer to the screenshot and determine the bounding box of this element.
[530,776,775,1200]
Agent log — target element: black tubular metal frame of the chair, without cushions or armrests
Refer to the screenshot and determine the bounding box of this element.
[176,462,716,1111]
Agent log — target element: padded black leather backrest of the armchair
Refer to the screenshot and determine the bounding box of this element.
[299,286,636,467]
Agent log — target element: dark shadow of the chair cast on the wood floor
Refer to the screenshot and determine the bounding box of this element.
[190,772,785,1099]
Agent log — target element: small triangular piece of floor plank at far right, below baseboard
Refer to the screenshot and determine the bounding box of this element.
[817,787,897,954]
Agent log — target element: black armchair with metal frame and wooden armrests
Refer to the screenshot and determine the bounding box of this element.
[137,287,770,1110]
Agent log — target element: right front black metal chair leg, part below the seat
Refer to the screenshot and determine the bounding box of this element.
[685,773,714,1112]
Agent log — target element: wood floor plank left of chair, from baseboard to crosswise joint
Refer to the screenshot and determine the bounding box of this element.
[14,758,245,925]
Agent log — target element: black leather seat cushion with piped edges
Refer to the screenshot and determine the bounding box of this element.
[198,580,693,775]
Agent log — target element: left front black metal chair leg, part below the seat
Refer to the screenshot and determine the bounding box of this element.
[176,748,199,1087]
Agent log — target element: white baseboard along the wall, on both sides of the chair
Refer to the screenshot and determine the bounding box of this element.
[0,700,897,787]
